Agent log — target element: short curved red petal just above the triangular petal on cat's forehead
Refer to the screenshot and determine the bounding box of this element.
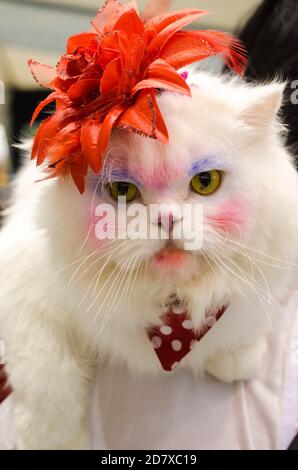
[132,59,191,96]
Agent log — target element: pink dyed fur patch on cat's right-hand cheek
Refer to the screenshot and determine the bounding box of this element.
[206,198,249,235]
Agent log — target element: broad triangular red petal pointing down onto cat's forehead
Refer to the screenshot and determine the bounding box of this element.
[117,91,169,144]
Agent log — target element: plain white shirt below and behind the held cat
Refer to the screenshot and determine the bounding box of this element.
[0,287,298,450]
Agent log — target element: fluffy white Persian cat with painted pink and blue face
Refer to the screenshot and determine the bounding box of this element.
[0,73,298,449]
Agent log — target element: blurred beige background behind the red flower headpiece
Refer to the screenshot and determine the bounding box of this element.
[0,0,261,201]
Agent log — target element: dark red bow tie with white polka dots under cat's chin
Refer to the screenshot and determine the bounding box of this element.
[148,303,227,372]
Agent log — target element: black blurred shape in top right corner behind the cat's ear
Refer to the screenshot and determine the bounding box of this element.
[239,0,298,163]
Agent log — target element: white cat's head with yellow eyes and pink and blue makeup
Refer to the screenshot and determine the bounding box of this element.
[77,76,296,281]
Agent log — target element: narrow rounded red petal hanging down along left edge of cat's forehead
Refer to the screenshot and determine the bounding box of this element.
[81,119,102,173]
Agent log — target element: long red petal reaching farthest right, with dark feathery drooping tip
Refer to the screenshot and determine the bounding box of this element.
[160,31,246,73]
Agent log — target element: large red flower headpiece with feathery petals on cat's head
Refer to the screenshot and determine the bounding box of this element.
[29,0,246,193]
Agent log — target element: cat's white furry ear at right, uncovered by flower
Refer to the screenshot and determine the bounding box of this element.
[240,83,285,129]
